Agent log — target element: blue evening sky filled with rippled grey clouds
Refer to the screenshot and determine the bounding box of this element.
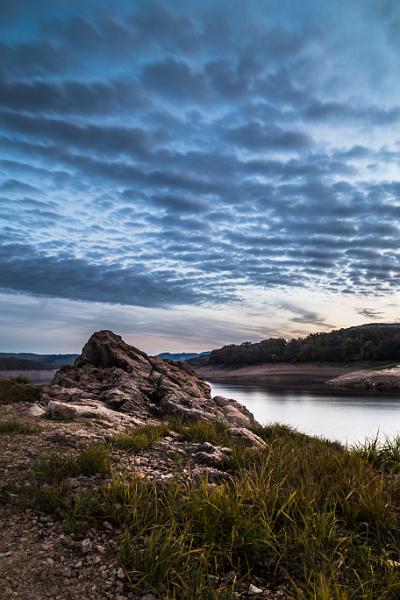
[0,0,400,353]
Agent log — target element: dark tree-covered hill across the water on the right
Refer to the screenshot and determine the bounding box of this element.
[208,323,400,366]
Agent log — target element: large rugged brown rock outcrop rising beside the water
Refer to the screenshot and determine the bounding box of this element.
[42,331,257,427]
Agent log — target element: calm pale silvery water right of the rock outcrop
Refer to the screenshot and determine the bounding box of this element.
[211,383,400,444]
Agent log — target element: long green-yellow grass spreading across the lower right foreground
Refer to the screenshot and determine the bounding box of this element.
[12,423,400,600]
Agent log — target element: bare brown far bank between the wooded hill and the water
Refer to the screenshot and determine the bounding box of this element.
[195,363,382,388]
